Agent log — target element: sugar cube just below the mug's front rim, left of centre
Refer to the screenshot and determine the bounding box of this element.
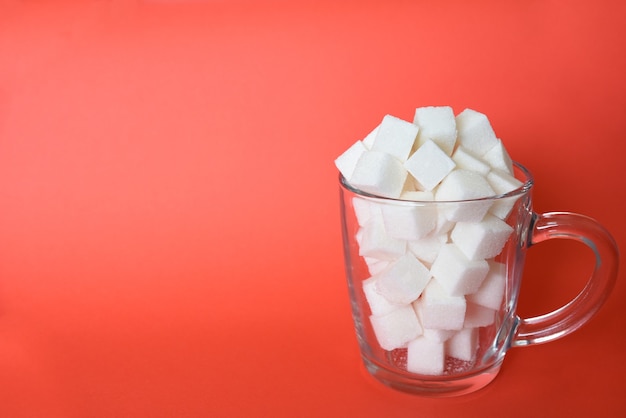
[381,202,437,240]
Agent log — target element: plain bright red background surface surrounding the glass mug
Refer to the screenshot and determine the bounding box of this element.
[0,0,626,418]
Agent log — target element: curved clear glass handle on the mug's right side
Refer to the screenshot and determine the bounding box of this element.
[512,212,619,347]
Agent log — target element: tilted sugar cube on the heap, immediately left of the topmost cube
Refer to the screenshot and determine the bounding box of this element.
[371,115,419,162]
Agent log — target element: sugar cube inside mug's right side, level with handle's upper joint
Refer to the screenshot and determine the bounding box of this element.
[450,213,513,260]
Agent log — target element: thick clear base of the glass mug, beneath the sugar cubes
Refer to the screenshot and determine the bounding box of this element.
[362,353,502,398]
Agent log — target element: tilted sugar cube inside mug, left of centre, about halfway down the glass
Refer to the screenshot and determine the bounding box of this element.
[376,254,430,304]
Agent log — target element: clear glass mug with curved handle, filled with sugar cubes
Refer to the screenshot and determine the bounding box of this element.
[340,163,619,396]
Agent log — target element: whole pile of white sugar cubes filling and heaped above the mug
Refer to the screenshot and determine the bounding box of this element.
[335,106,522,375]
